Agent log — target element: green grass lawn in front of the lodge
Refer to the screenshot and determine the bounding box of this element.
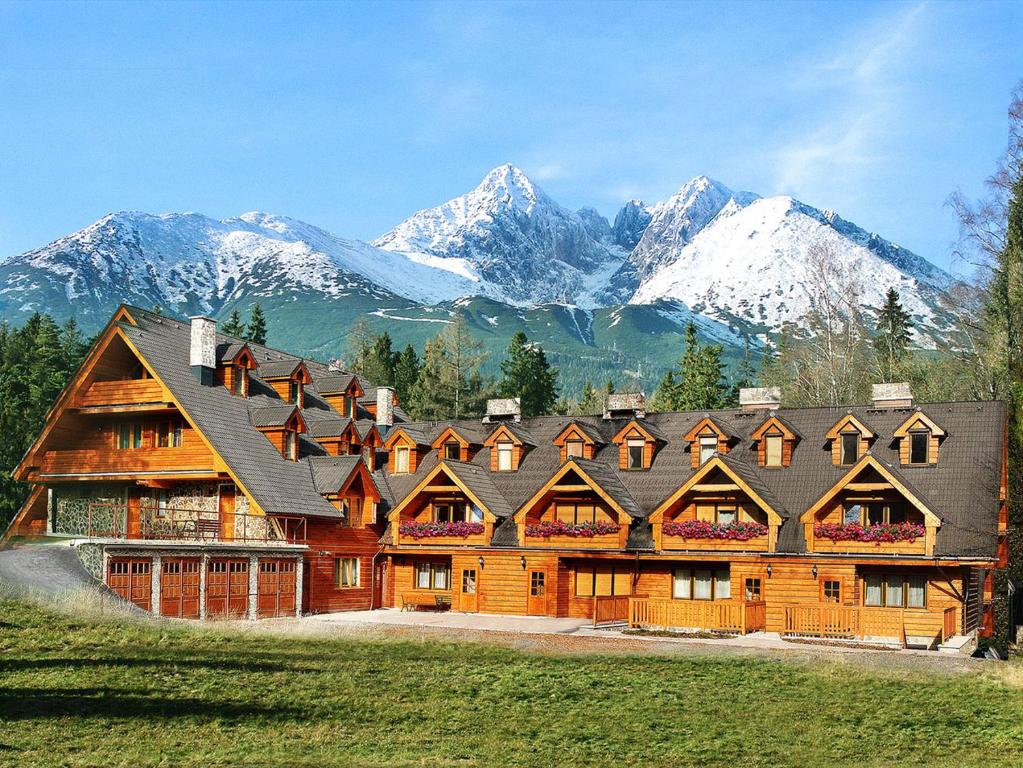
[0,599,1023,768]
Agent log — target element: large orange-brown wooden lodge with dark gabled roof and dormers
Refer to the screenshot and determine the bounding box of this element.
[0,307,1008,646]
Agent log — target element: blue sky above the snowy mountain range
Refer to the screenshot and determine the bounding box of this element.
[0,0,1023,274]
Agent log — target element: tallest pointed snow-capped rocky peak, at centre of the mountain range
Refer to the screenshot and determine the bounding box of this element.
[373,164,626,308]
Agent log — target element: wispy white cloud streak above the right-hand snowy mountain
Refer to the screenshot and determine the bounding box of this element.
[775,3,928,198]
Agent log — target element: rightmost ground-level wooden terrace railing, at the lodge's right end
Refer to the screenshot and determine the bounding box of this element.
[785,602,957,647]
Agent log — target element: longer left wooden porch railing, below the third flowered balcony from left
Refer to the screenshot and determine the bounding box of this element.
[629,597,767,635]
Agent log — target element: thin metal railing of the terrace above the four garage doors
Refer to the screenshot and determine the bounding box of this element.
[84,502,306,544]
